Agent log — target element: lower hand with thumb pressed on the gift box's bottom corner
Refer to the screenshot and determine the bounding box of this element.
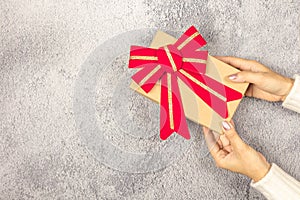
[203,121,271,182]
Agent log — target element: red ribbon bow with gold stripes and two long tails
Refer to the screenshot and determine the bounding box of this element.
[129,26,242,140]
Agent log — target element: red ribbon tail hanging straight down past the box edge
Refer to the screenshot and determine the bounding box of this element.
[160,73,190,140]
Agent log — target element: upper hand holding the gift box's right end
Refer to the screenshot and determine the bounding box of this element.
[216,56,294,101]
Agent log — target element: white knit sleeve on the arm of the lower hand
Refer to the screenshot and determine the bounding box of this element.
[250,163,300,200]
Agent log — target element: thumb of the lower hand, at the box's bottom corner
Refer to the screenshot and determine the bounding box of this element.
[222,121,245,148]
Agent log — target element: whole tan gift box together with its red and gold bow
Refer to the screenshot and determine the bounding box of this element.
[129,26,248,139]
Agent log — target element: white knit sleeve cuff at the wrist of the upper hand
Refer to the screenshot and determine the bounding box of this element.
[282,74,300,113]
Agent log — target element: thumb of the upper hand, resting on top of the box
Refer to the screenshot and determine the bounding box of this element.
[228,71,264,85]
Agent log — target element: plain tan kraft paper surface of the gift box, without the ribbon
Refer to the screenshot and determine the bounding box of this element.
[130,27,248,139]
